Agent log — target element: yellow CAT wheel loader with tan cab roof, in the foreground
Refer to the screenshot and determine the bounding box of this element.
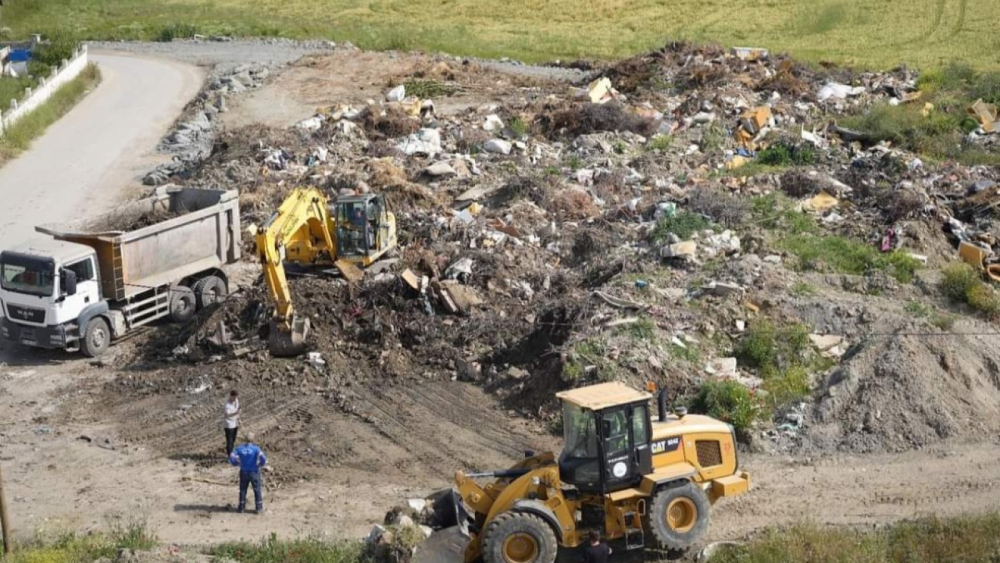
[414,383,750,563]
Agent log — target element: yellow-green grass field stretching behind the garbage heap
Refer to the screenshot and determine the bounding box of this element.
[3,0,1000,68]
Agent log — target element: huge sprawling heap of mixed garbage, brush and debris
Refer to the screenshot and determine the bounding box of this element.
[127,43,1000,452]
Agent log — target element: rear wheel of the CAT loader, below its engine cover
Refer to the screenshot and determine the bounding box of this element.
[649,481,709,550]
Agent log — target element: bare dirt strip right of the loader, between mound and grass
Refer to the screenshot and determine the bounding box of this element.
[709,444,1000,539]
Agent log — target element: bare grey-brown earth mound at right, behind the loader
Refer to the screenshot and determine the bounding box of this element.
[810,334,1000,452]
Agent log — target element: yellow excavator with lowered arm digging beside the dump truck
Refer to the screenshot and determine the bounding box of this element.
[256,188,397,356]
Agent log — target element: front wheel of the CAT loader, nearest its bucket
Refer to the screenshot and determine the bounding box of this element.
[483,512,559,563]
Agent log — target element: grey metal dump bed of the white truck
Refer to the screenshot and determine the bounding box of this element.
[35,186,241,300]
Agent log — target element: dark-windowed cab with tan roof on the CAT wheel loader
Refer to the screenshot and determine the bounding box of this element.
[556,383,653,494]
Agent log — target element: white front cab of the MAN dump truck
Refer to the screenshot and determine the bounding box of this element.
[0,239,111,351]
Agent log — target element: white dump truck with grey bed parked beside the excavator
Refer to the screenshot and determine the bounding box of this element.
[0,186,241,357]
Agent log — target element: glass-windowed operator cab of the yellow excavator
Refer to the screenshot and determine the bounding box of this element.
[330,194,396,266]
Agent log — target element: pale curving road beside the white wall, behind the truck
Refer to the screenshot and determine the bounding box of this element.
[0,51,203,242]
